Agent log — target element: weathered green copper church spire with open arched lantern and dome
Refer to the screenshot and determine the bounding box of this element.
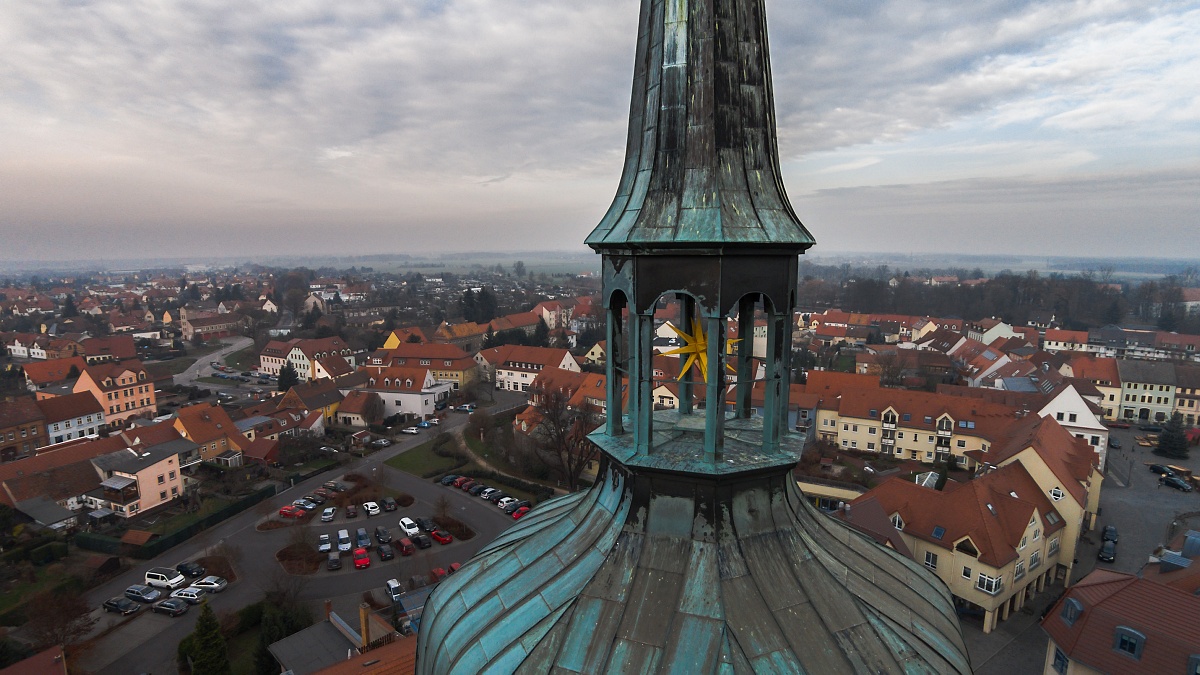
[418,0,971,675]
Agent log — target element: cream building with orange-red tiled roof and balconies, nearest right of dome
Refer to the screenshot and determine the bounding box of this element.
[851,464,1074,633]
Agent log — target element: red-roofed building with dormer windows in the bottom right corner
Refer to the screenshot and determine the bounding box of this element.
[1042,569,1200,675]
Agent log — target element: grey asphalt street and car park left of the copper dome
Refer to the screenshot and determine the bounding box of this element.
[78,403,512,675]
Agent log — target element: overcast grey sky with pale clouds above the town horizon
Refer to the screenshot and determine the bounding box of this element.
[0,0,1200,259]
